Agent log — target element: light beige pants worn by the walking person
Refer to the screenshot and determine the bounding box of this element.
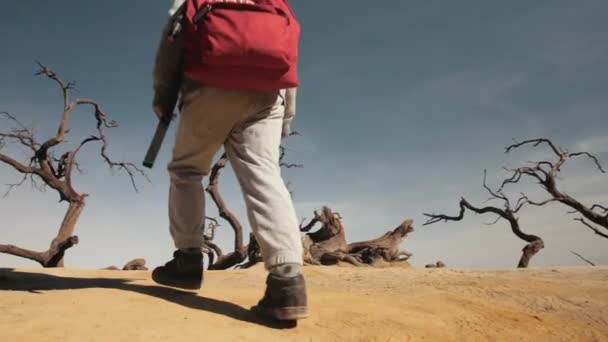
[168,84,302,268]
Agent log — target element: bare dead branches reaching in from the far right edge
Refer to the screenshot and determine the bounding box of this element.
[501,138,608,239]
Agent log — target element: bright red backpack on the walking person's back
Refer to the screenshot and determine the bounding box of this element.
[182,0,300,91]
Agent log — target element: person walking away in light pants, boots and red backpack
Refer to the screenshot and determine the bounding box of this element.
[152,0,308,320]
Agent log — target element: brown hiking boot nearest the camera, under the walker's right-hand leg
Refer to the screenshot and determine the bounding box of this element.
[251,273,308,321]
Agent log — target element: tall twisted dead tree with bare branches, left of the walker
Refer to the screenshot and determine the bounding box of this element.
[0,63,146,267]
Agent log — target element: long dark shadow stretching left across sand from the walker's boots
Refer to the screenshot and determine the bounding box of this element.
[0,268,297,329]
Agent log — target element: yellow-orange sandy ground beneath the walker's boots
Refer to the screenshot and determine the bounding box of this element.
[0,267,608,342]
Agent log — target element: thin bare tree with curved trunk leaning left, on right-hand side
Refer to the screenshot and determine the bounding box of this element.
[424,171,549,268]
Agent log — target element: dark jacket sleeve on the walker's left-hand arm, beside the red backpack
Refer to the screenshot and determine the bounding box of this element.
[152,0,184,110]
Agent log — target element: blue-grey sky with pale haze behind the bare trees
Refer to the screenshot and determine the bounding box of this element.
[0,0,608,268]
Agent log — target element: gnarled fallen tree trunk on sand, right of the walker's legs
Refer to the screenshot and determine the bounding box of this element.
[300,207,414,266]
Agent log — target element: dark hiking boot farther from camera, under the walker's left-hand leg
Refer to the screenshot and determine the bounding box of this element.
[152,250,203,290]
